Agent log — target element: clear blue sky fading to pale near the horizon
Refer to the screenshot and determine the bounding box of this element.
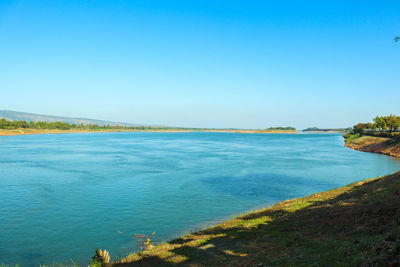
[0,0,400,128]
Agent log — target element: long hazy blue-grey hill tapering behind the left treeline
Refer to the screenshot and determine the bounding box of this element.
[0,110,138,126]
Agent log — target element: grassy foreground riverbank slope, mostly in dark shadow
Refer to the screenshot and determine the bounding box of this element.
[115,172,400,266]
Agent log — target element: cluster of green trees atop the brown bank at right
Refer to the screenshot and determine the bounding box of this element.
[352,115,400,137]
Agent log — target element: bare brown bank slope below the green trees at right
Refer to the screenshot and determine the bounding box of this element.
[343,133,400,159]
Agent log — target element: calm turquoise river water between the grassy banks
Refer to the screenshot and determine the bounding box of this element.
[0,133,400,266]
